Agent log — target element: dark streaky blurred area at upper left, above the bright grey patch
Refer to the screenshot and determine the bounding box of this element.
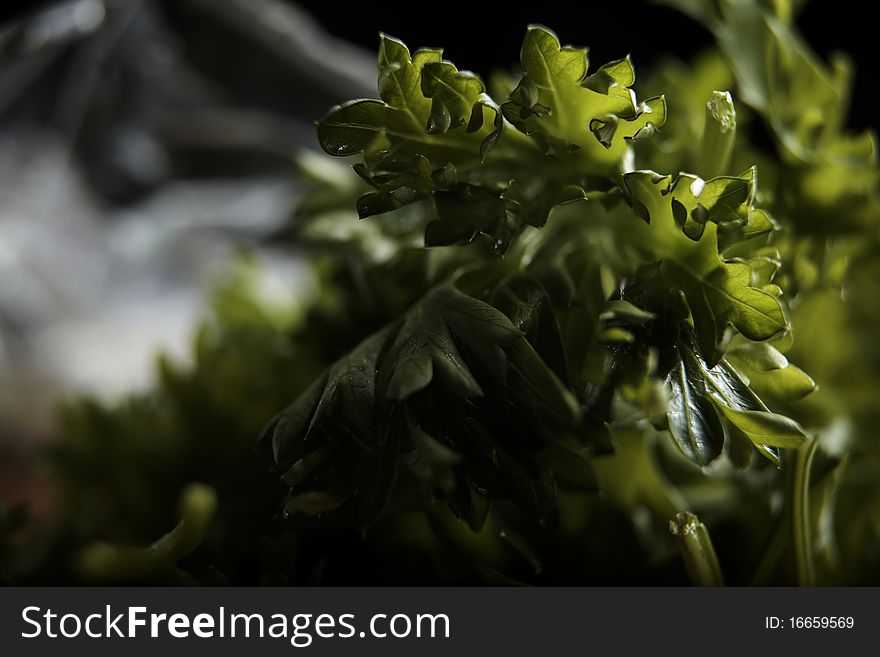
[0,0,376,203]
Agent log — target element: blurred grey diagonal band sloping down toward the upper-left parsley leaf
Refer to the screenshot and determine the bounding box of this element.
[186,0,377,98]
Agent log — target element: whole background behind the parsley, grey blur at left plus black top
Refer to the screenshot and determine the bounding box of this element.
[0,0,876,584]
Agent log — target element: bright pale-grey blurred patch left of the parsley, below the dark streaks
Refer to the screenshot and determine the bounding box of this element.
[0,137,300,415]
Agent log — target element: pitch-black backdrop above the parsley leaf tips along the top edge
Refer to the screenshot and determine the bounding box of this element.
[0,0,877,129]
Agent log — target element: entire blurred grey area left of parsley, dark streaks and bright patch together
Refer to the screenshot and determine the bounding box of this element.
[0,0,376,468]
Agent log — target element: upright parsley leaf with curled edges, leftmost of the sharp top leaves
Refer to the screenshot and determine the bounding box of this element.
[318,35,504,223]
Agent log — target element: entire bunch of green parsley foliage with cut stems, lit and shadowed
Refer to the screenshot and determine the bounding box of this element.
[8,0,880,584]
